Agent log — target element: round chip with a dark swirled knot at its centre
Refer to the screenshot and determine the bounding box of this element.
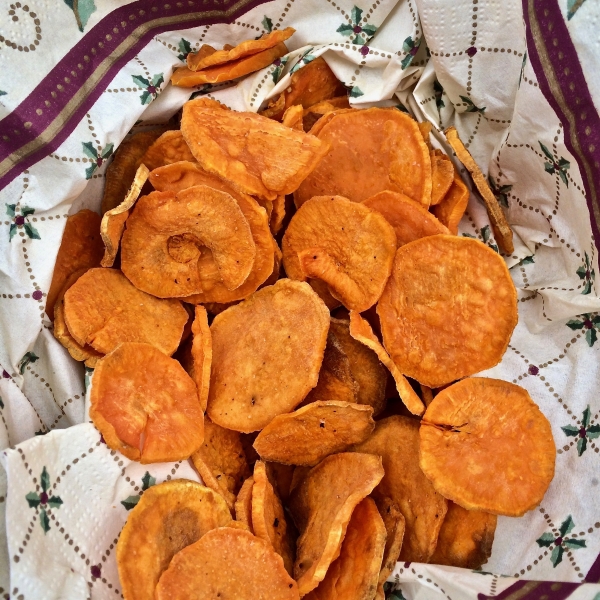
[121,186,255,298]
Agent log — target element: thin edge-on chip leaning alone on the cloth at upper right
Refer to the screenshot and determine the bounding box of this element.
[445,127,514,254]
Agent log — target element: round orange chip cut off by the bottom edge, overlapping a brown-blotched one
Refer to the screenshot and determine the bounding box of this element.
[151,527,300,600]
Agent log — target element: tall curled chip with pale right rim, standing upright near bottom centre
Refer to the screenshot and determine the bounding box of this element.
[290,452,384,596]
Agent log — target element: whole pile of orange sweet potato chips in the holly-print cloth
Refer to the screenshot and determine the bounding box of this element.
[47,29,555,600]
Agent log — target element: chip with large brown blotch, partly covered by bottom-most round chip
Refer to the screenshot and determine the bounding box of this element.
[117,479,232,600]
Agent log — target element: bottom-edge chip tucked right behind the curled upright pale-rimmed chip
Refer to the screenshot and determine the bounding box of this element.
[306,498,386,600]
